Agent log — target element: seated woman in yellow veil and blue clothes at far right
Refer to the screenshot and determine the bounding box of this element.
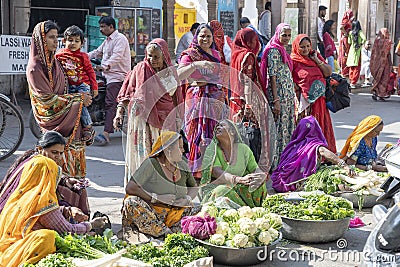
[340,115,387,172]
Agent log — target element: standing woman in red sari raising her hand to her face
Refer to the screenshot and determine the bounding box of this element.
[290,34,336,153]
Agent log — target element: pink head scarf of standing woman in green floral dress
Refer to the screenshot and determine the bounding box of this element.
[261,23,293,83]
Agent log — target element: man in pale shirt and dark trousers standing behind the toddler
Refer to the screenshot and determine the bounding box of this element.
[89,17,131,145]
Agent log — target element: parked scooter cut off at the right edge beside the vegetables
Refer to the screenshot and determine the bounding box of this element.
[363,146,400,267]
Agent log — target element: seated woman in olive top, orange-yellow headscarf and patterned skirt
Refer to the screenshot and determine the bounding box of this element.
[122,131,201,240]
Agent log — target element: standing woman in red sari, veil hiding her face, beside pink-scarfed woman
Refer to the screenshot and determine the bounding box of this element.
[229,28,276,171]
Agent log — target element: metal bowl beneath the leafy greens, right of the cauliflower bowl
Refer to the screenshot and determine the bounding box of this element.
[281,216,350,243]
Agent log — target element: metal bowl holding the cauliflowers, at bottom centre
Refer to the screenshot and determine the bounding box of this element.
[197,233,282,266]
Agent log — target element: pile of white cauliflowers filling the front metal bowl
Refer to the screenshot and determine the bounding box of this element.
[199,204,282,248]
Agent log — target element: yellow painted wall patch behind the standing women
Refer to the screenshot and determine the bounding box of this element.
[174,3,196,40]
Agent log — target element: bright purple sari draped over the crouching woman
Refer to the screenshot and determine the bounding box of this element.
[271,116,327,192]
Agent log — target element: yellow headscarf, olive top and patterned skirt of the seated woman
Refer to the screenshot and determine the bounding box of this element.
[122,131,201,237]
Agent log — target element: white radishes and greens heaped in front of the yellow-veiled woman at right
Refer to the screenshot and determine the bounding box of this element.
[304,166,388,196]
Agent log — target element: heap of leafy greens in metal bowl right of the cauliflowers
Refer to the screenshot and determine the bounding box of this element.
[263,194,354,220]
